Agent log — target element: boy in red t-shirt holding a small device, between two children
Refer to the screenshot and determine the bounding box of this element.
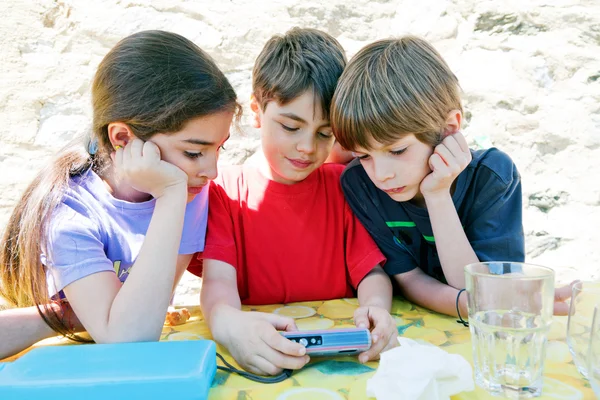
[191,28,397,374]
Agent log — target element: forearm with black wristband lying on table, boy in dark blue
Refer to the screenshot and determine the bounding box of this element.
[394,268,467,319]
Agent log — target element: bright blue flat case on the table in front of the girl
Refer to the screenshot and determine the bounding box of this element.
[0,340,216,400]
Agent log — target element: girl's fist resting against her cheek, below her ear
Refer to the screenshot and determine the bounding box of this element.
[114,138,187,198]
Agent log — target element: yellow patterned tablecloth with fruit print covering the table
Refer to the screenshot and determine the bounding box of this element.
[7,299,594,400]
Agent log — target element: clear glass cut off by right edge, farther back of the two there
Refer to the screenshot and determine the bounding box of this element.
[567,282,600,378]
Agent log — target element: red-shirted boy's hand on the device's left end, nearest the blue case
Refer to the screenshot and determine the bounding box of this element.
[223,311,310,375]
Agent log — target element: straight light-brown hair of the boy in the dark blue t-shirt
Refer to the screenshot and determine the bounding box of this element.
[331,36,462,150]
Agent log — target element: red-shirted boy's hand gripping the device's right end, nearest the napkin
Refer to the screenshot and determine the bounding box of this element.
[354,306,398,363]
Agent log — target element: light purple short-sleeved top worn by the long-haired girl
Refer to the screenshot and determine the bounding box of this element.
[41,170,208,296]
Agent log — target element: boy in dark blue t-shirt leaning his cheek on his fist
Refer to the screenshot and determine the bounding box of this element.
[331,36,570,315]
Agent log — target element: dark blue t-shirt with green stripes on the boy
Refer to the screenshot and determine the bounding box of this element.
[341,148,525,282]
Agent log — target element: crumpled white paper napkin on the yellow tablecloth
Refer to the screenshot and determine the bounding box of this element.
[367,338,475,400]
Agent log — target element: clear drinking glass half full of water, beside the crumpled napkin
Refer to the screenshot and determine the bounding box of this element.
[465,262,554,398]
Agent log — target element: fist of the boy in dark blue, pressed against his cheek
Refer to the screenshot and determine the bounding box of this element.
[420,132,472,198]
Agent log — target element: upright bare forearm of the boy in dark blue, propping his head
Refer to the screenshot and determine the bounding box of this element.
[425,193,479,289]
